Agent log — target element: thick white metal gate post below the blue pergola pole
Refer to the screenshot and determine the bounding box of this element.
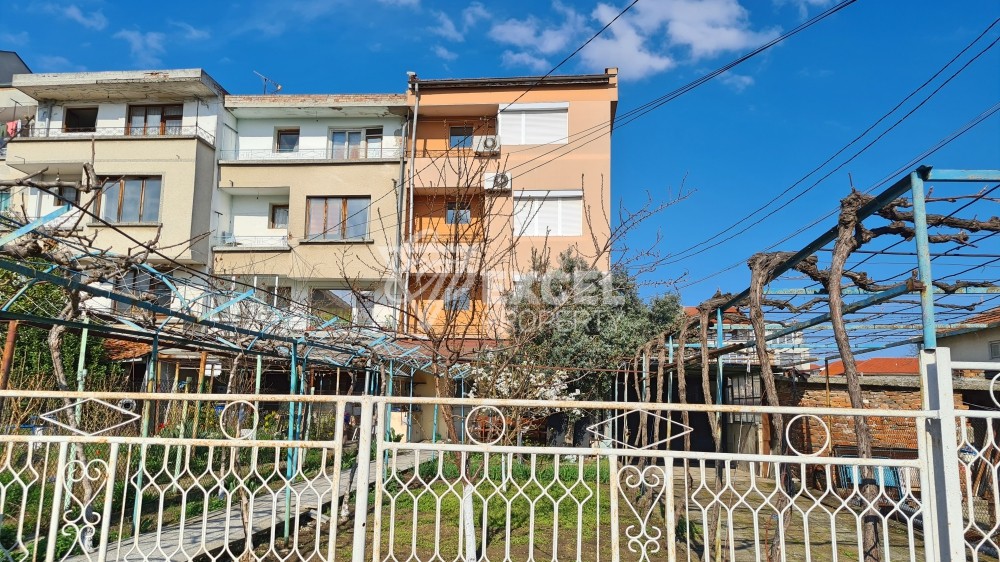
[920,347,965,560]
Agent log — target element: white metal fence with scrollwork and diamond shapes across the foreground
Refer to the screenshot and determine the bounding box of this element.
[0,350,1000,561]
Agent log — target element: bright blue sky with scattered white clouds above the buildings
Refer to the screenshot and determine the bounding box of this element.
[0,0,1000,303]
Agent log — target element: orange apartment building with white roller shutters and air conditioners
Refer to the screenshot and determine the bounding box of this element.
[403,65,618,338]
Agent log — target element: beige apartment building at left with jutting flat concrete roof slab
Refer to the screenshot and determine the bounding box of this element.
[5,69,225,268]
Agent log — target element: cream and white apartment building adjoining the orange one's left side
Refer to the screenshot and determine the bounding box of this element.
[213,94,407,329]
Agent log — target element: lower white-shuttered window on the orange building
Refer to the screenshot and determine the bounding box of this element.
[514,192,583,236]
